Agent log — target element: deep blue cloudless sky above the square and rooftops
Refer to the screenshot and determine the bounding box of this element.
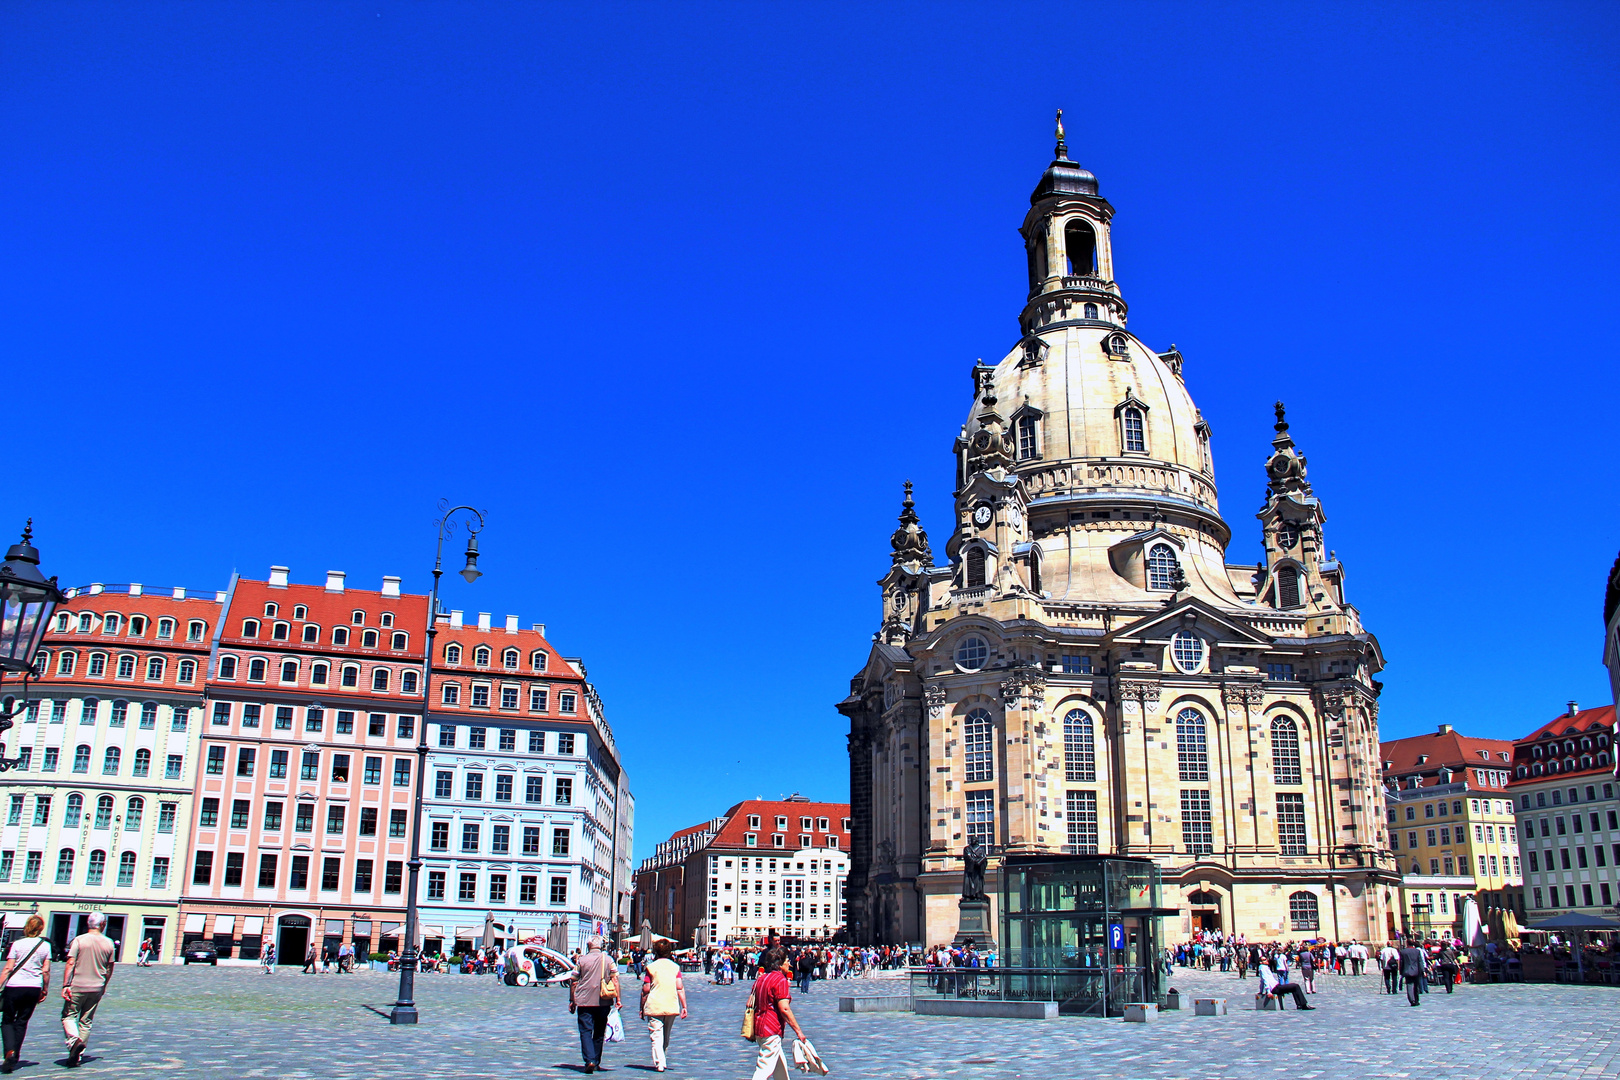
[0,3,1620,855]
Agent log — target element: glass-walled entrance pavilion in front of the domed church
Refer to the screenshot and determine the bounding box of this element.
[998,855,1179,1017]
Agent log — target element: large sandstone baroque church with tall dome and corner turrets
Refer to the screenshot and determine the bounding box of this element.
[838,112,1398,944]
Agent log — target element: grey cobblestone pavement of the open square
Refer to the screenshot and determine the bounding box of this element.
[6,965,1620,1080]
